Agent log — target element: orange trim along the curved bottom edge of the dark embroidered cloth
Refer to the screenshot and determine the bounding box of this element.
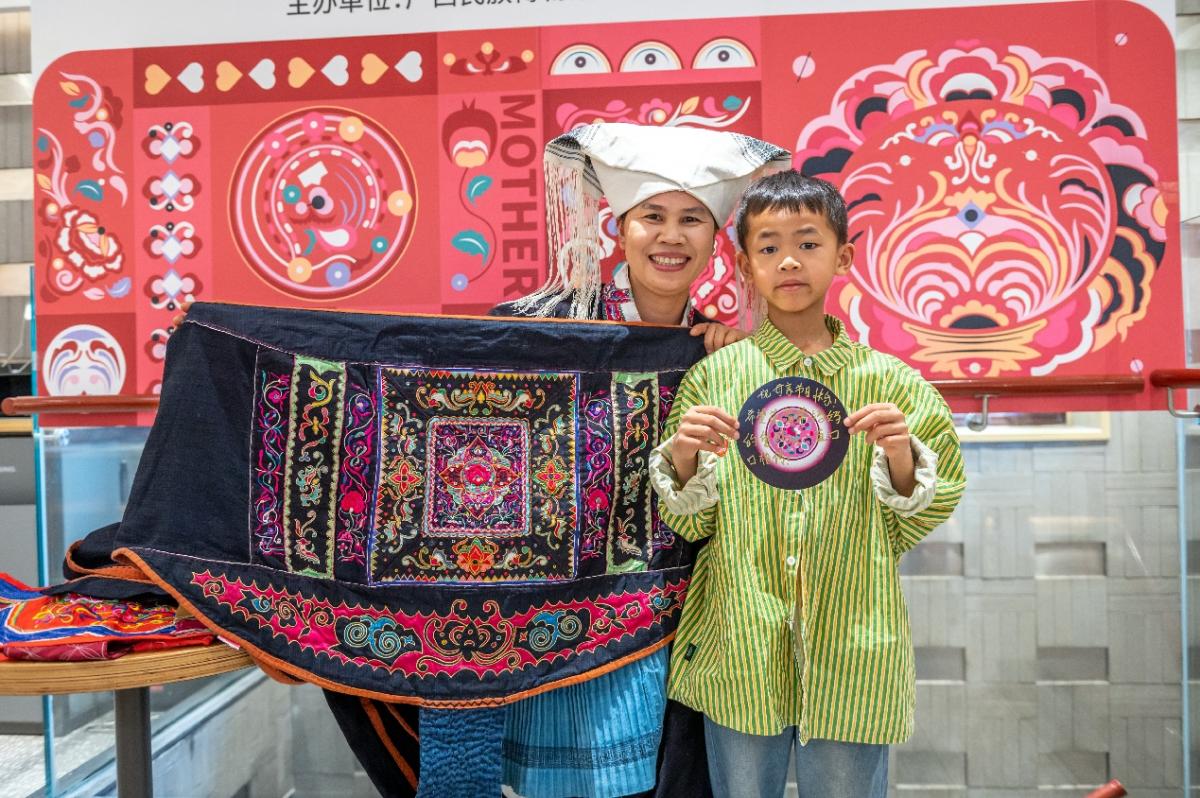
[113,548,674,709]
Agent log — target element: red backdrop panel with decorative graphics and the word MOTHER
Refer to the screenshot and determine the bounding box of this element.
[35,1,1183,417]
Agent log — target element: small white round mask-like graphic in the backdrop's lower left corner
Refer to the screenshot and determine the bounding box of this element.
[42,324,125,396]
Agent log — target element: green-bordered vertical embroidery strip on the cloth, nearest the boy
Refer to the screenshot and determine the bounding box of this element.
[608,373,660,574]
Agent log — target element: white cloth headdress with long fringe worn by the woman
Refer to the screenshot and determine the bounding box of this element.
[515,122,792,318]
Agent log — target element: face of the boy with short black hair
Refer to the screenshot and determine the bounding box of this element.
[738,209,854,314]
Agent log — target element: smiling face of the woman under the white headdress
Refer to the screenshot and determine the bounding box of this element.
[619,191,716,303]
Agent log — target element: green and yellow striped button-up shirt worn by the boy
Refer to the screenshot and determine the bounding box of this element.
[660,317,965,744]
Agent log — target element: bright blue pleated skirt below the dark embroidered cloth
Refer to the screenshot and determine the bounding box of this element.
[504,648,668,798]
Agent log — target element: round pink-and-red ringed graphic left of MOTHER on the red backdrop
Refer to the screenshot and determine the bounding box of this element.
[229,108,416,299]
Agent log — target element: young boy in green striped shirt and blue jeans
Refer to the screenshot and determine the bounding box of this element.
[650,170,965,798]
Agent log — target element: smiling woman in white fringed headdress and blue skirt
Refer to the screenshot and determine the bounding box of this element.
[492,124,791,798]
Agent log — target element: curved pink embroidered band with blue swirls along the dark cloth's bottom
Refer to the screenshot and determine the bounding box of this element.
[191,570,688,685]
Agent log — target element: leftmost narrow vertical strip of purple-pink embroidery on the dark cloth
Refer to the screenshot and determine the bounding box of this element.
[250,358,292,562]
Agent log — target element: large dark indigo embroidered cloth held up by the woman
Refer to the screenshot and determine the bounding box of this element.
[65,304,702,792]
